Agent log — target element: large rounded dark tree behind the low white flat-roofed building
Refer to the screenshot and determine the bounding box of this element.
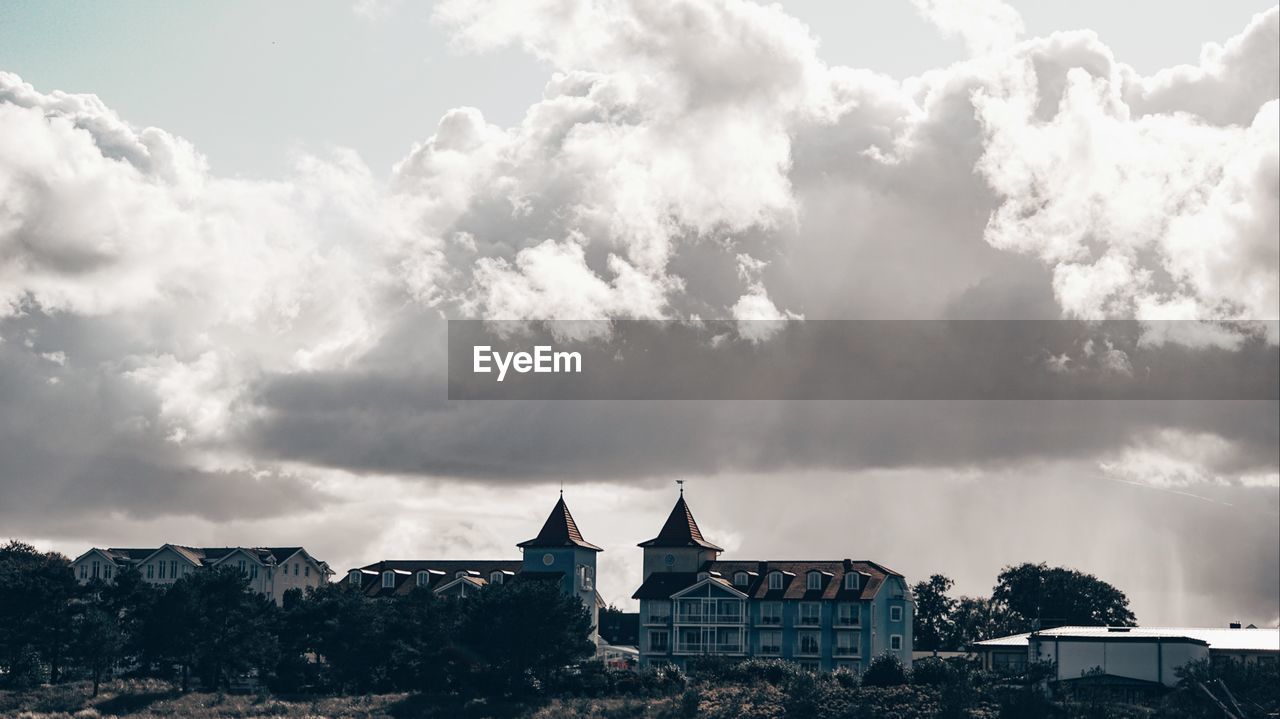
[992,563,1135,632]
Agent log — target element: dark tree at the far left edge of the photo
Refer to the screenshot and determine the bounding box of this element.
[0,541,81,684]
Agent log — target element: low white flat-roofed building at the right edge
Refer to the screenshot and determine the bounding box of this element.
[973,626,1280,687]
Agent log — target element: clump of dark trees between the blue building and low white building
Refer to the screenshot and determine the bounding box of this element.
[911,563,1137,651]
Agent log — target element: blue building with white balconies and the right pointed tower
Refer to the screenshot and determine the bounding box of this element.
[632,491,914,672]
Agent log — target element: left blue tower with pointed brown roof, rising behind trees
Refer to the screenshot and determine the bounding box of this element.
[516,490,603,641]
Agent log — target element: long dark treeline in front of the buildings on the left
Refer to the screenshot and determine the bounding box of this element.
[0,541,594,695]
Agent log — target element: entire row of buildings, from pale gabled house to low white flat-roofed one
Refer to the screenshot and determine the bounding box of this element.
[73,490,1280,687]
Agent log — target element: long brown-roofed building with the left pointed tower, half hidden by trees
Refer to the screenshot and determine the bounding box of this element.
[342,493,603,644]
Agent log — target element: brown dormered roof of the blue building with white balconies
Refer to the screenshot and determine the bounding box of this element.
[631,559,901,600]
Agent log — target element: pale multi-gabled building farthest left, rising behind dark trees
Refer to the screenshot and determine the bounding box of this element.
[72,544,333,604]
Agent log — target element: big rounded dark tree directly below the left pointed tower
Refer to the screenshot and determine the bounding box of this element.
[458,580,594,690]
